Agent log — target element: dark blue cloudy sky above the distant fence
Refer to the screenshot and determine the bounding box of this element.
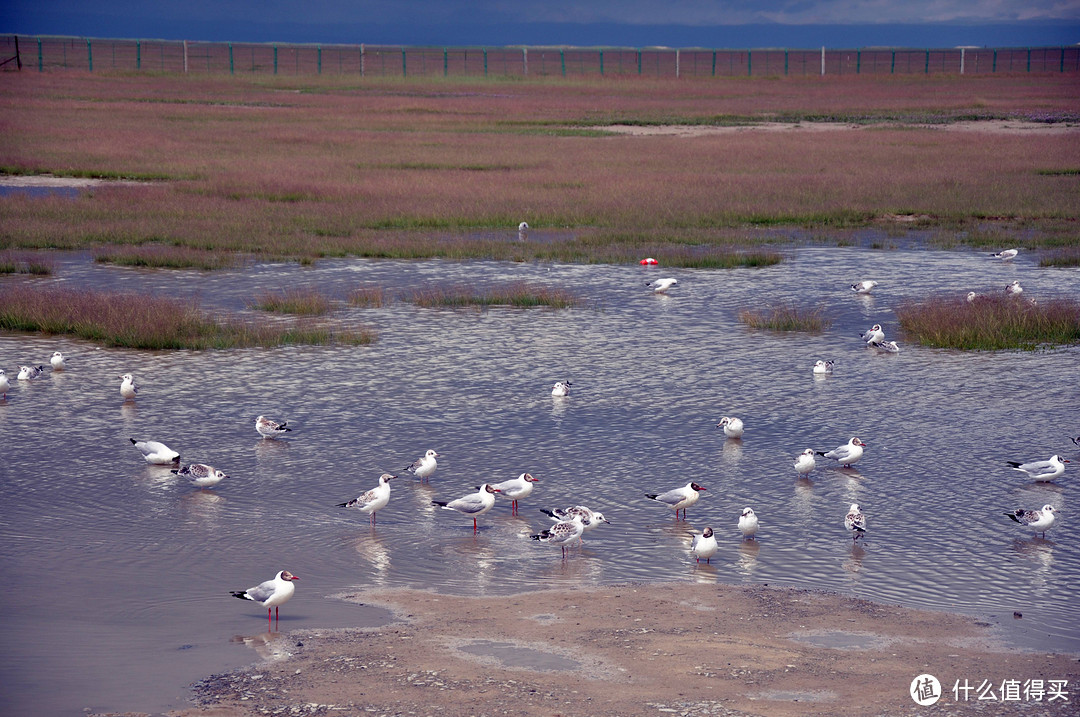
[0,0,1080,48]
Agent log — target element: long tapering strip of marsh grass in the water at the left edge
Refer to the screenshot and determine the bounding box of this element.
[0,284,376,350]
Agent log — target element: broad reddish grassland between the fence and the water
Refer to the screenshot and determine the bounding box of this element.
[0,72,1080,266]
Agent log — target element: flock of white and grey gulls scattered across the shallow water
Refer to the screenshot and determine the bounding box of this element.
[6,244,1080,624]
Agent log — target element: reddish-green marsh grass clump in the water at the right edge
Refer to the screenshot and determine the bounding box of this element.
[896,295,1080,351]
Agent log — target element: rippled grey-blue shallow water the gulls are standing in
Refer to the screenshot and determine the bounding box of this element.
[0,247,1080,714]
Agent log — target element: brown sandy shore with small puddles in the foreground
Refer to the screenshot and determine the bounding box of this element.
[166,584,1080,717]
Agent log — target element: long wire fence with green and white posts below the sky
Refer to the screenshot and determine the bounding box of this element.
[0,35,1080,78]
